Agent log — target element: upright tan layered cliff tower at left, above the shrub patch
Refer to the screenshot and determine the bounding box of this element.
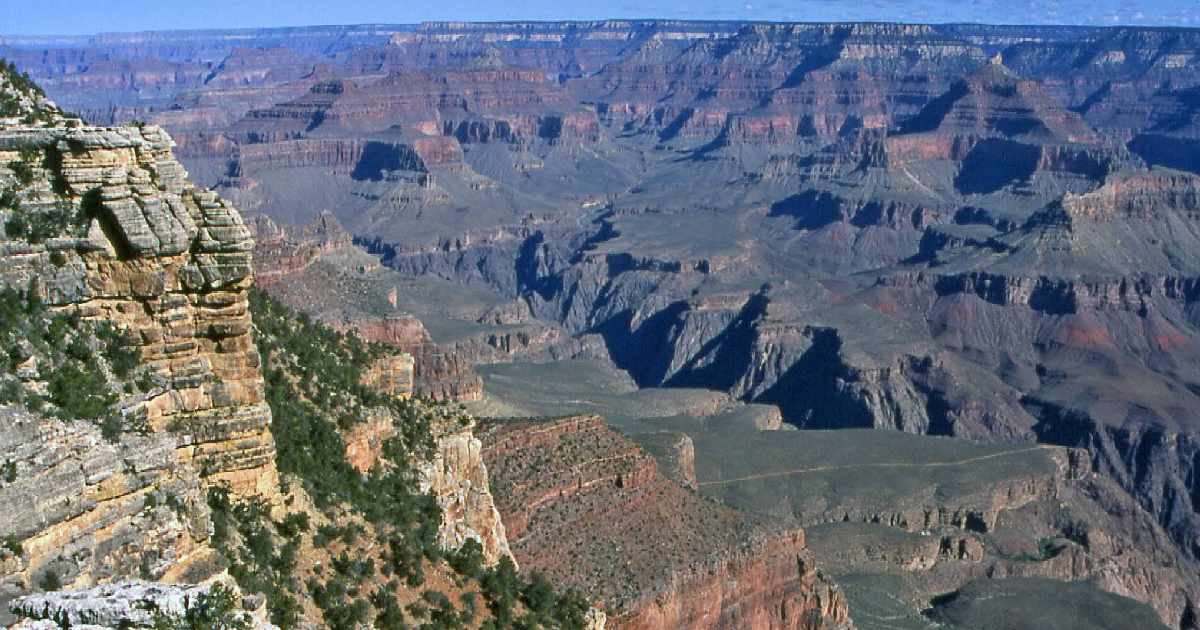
[0,121,277,493]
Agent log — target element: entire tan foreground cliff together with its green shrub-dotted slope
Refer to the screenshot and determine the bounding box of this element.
[0,64,604,629]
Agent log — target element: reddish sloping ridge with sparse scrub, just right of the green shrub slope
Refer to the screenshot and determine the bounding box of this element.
[482,416,850,629]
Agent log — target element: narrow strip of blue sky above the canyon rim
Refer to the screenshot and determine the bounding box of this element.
[0,0,1200,35]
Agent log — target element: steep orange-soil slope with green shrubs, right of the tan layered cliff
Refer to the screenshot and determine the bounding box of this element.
[209,286,588,629]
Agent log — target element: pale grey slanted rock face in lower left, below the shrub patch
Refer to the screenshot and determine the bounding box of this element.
[0,407,220,619]
